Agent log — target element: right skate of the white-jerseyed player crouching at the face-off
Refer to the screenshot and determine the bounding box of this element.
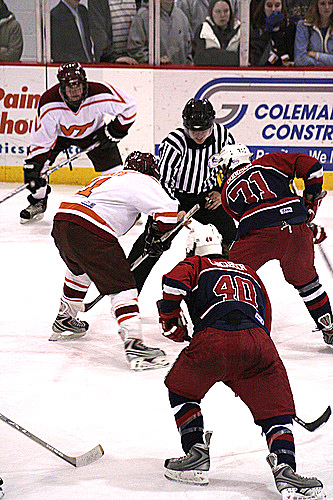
[120,333,169,371]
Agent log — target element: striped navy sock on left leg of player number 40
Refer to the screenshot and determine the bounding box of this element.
[169,390,204,453]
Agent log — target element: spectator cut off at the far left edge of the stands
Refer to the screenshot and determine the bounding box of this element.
[0,0,23,61]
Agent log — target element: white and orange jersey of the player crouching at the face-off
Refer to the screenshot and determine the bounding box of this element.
[55,170,178,237]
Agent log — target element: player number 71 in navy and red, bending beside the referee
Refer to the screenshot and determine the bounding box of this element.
[217,144,333,346]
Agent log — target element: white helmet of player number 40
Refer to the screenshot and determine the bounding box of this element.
[186,221,222,257]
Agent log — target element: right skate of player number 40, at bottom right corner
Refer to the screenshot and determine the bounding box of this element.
[266,453,326,500]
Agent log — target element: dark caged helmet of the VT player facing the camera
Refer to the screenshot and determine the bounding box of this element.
[57,62,88,111]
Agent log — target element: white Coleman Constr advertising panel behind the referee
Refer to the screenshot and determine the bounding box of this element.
[155,70,333,171]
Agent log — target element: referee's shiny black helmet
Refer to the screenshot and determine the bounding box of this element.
[182,99,215,130]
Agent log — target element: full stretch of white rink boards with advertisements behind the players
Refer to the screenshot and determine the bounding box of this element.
[0,64,333,183]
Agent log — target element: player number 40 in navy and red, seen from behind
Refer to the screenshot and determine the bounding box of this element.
[157,222,325,499]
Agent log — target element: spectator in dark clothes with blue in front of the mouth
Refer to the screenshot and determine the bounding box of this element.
[250,0,296,66]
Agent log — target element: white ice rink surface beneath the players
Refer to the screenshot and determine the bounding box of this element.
[0,183,333,500]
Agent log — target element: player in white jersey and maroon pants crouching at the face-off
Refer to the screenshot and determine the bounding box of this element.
[50,151,180,370]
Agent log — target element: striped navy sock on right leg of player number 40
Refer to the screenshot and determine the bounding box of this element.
[256,415,296,471]
